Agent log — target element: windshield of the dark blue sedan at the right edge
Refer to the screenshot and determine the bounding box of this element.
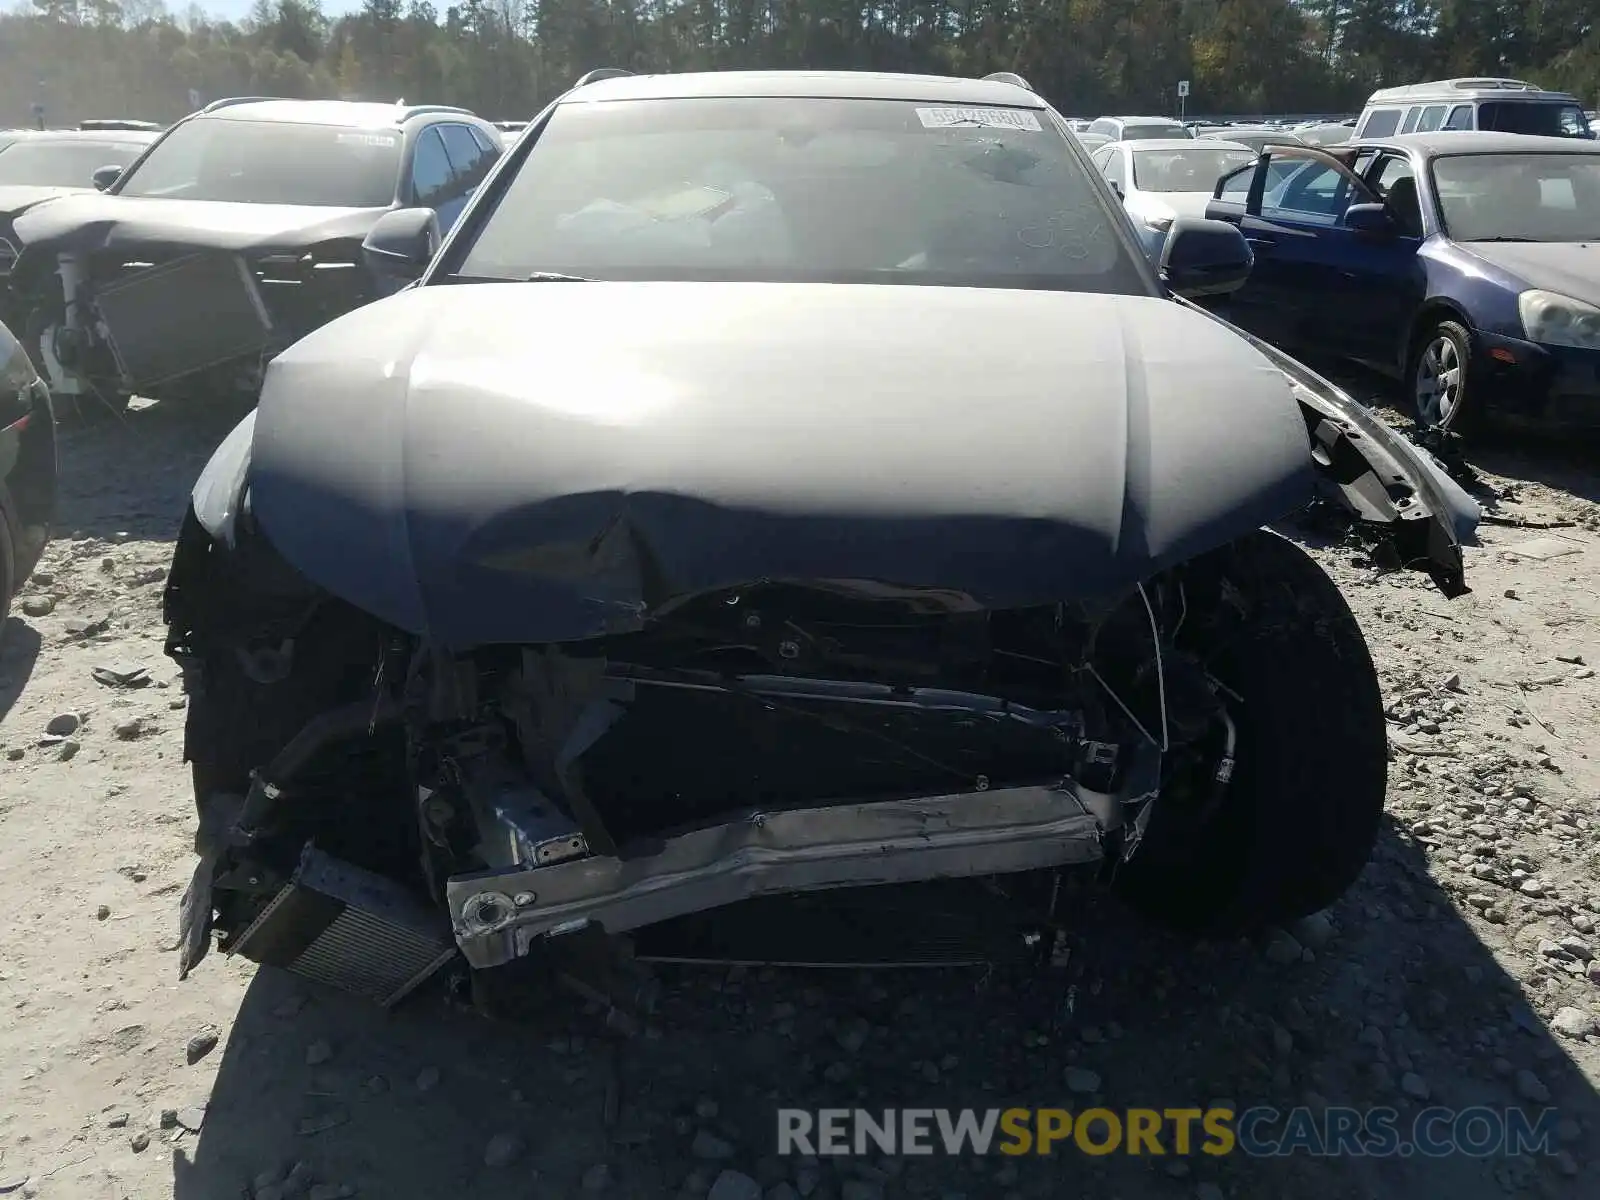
[1432,154,1600,242]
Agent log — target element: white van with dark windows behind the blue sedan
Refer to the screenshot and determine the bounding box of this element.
[1355,78,1594,138]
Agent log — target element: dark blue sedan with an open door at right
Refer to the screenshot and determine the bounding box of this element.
[1206,131,1600,434]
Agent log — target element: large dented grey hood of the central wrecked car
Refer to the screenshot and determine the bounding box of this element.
[249,282,1314,648]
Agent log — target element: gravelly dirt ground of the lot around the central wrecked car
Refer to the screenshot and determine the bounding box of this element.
[0,387,1600,1200]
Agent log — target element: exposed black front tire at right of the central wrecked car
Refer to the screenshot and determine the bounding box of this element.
[1112,533,1389,936]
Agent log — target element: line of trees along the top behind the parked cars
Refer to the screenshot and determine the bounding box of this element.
[0,0,1600,126]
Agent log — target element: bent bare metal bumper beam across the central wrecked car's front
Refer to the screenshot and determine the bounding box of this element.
[446,781,1120,968]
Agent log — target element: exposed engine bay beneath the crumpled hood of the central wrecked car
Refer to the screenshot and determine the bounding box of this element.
[168,530,1243,1003]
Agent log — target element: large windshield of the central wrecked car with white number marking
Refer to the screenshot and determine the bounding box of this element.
[459,98,1147,294]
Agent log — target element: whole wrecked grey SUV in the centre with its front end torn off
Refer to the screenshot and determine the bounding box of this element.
[166,72,1475,1003]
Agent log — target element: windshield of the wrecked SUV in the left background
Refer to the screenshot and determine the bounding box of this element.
[117,117,400,208]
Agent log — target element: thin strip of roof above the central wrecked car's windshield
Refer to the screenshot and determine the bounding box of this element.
[562,70,1045,109]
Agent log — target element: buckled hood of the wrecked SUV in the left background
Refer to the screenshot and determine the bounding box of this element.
[16,192,387,251]
